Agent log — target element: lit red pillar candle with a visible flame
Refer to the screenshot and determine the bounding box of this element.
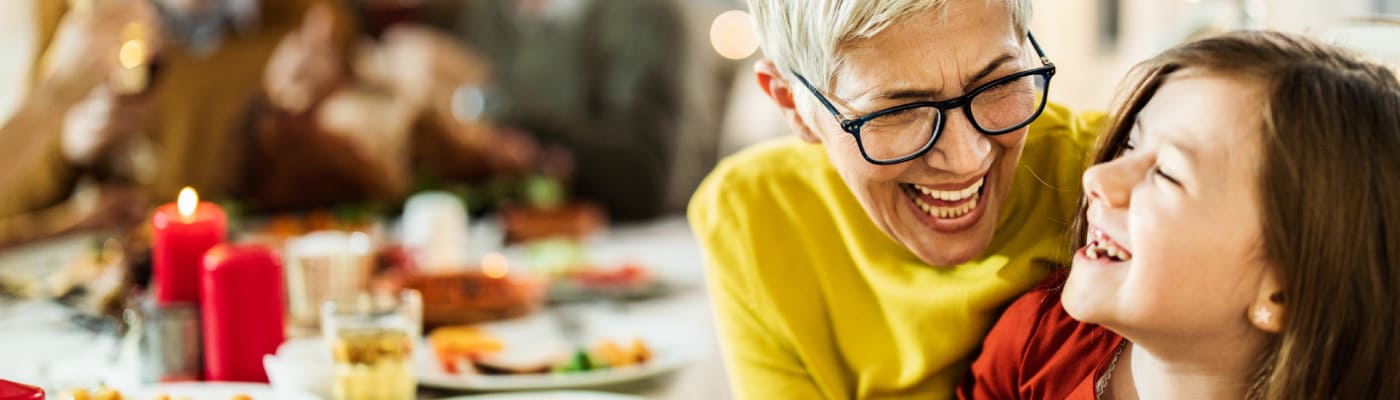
[151,187,228,303]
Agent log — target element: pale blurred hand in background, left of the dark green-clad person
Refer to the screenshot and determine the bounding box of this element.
[354,25,490,115]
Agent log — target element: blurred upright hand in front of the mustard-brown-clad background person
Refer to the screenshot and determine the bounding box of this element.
[263,3,346,113]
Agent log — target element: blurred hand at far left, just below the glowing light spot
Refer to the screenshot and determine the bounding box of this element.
[63,84,151,165]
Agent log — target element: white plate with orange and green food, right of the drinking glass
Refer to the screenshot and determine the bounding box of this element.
[414,312,693,392]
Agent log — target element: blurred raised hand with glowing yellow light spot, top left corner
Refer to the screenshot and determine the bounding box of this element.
[38,0,161,103]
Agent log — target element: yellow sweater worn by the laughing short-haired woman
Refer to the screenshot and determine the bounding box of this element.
[689,105,1102,399]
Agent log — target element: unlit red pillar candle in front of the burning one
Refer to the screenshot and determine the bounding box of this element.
[200,245,286,382]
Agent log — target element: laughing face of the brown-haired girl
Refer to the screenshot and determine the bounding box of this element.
[1063,69,1282,341]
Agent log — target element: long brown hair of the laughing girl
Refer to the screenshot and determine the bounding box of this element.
[1072,31,1400,399]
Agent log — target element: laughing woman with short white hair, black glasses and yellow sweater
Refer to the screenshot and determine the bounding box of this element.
[689,0,1099,399]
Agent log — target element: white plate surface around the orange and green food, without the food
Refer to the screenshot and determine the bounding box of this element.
[413,315,694,392]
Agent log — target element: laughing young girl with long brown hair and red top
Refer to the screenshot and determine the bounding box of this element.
[959,32,1400,399]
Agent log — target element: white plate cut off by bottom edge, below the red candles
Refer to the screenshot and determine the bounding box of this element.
[67,382,321,400]
